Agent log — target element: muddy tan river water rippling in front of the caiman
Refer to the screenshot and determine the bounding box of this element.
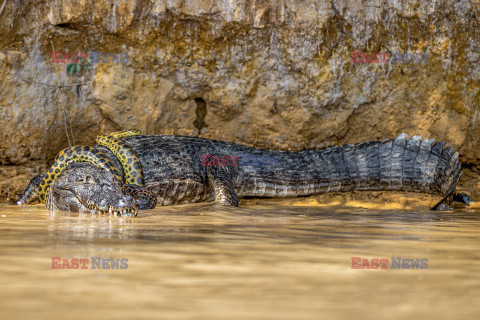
[0,204,480,319]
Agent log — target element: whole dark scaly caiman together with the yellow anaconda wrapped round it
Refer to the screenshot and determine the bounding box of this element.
[17,130,471,215]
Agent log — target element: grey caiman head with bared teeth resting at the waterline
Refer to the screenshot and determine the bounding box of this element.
[46,162,138,215]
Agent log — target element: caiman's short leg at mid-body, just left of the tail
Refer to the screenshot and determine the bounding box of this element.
[208,167,238,207]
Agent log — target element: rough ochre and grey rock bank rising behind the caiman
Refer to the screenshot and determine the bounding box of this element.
[0,0,480,200]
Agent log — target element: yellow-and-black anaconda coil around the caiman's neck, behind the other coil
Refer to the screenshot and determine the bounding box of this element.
[96,129,145,187]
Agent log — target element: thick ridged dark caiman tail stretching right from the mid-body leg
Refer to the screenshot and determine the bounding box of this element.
[238,134,461,197]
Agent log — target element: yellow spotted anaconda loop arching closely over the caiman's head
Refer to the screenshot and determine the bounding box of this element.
[38,146,123,203]
